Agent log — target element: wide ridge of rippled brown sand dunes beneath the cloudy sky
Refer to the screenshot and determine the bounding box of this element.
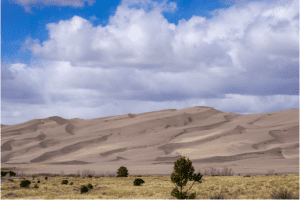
[1,106,299,175]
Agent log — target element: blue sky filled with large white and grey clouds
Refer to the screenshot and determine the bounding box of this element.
[1,0,299,125]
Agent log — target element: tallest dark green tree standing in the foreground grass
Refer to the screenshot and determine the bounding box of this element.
[171,157,202,199]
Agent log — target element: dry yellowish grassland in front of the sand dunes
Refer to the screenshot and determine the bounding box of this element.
[1,168,299,199]
